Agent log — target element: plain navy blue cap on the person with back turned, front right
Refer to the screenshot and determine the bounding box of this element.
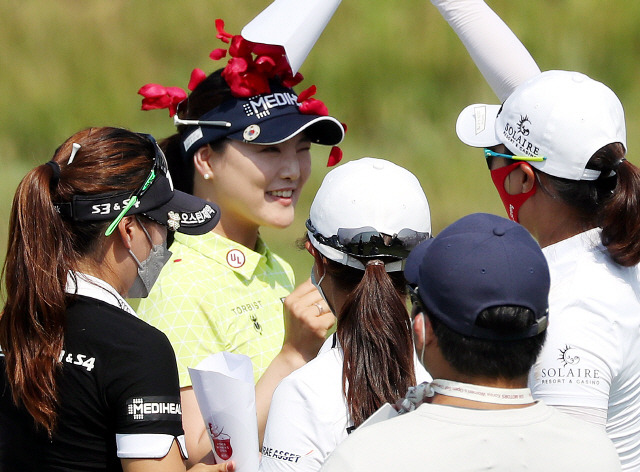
[404,213,550,340]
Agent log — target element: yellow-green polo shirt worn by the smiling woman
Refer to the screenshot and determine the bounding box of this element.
[137,232,294,387]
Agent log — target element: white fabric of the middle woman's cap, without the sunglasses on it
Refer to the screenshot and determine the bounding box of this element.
[307,157,431,267]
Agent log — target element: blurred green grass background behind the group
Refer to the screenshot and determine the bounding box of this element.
[0,0,640,290]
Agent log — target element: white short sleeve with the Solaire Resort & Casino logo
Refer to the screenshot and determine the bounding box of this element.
[529,300,622,412]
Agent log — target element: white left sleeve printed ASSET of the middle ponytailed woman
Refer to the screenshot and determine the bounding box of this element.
[259,377,337,472]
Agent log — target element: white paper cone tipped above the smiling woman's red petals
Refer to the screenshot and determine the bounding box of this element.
[241,0,341,74]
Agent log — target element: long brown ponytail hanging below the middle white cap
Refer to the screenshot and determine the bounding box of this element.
[325,260,416,426]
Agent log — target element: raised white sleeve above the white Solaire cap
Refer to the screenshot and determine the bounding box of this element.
[431,0,540,102]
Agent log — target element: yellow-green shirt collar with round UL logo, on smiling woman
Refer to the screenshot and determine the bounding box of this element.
[175,231,273,279]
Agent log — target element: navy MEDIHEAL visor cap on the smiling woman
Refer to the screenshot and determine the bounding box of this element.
[176,82,344,159]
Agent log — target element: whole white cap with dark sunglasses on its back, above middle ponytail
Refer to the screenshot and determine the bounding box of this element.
[307,157,431,272]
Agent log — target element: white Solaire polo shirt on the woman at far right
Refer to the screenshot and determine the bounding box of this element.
[529,229,640,470]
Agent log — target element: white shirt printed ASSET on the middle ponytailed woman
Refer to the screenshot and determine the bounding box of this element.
[260,334,432,472]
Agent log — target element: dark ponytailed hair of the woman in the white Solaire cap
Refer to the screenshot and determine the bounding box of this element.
[545,143,640,267]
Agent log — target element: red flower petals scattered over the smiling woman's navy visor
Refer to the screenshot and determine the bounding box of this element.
[138,19,347,167]
